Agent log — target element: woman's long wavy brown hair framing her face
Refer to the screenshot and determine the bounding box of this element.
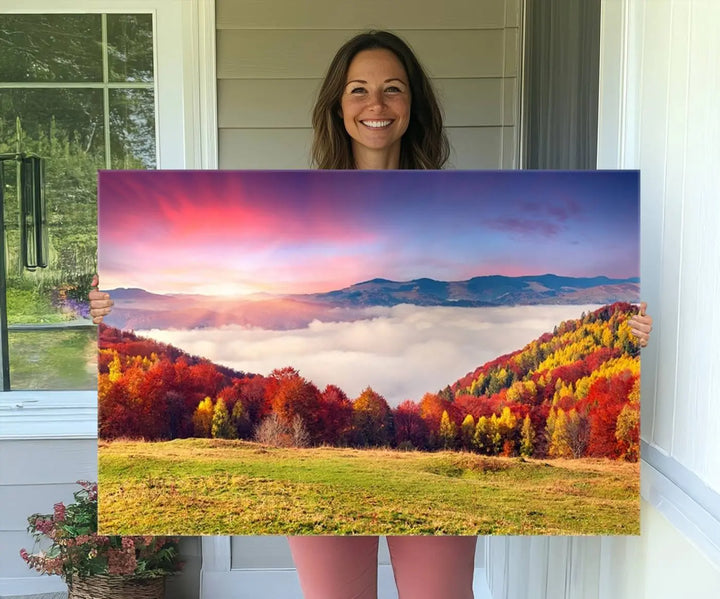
[312,31,450,169]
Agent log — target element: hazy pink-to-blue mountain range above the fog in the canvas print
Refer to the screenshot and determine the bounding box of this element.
[107,274,640,330]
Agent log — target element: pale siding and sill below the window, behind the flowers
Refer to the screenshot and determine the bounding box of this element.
[0,391,97,597]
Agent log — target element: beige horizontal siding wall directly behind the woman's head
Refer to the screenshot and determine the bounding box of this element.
[217,0,520,169]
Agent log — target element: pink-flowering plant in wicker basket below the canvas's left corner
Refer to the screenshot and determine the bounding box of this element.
[20,481,182,599]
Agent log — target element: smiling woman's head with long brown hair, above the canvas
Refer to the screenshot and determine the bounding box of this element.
[312,31,450,169]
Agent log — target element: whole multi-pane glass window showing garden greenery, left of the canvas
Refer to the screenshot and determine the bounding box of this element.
[0,14,157,390]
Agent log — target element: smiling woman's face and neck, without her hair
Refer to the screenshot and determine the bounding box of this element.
[340,48,411,161]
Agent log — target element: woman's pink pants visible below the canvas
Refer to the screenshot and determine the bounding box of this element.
[289,536,477,599]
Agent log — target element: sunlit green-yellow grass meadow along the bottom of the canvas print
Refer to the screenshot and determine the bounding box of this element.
[99,439,640,535]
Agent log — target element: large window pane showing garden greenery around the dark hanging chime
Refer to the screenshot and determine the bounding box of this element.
[0,89,105,324]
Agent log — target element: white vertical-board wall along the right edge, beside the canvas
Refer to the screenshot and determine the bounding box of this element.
[623,0,720,493]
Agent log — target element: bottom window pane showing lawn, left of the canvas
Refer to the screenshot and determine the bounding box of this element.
[9,326,97,389]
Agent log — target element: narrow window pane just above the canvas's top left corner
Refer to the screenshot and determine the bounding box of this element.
[110,89,156,169]
